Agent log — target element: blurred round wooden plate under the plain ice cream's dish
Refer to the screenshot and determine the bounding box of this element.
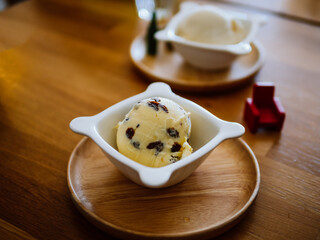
[130,36,264,92]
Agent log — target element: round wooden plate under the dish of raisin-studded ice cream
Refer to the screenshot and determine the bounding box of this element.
[68,138,260,239]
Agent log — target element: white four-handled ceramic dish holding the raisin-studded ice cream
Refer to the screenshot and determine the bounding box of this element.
[70,83,245,188]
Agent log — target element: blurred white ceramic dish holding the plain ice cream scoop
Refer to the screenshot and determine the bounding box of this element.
[155,2,266,70]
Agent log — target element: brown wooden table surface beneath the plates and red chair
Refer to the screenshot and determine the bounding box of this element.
[0,0,320,239]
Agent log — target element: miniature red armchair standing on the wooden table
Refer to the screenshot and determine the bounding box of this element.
[244,82,286,133]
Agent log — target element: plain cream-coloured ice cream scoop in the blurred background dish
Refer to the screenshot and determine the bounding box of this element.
[176,6,246,44]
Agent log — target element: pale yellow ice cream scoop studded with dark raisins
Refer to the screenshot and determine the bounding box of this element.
[117,97,192,167]
